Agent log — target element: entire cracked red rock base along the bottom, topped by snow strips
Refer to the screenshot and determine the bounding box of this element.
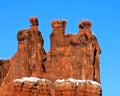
[0,77,102,96]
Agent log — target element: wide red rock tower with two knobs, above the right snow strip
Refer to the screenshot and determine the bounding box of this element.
[46,20,101,82]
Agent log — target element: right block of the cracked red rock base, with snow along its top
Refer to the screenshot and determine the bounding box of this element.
[54,79,101,96]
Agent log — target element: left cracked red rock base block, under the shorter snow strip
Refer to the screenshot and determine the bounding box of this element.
[13,80,52,96]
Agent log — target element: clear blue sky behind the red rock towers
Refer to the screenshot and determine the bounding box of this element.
[0,0,120,96]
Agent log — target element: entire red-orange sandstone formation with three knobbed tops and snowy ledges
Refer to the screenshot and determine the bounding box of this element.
[0,17,102,96]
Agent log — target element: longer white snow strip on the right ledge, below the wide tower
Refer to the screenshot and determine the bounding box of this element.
[56,78,100,86]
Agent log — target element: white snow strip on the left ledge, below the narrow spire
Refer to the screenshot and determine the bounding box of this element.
[14,77,48,82]
